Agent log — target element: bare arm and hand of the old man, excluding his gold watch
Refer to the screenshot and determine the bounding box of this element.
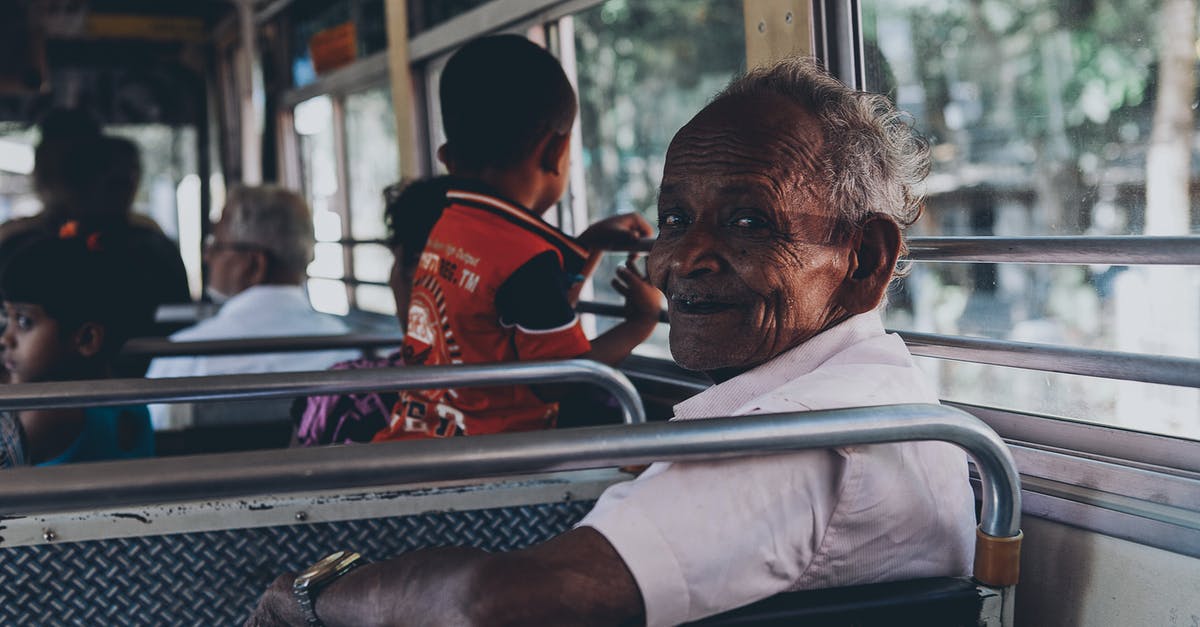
[246,527,643,627]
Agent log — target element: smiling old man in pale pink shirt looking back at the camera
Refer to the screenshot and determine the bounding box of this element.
[243,60,974,626]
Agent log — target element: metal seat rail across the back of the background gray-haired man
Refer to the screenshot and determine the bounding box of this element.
[121,334,404,357]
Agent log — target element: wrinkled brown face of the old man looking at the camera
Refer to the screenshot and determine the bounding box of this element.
[648,96,850,380]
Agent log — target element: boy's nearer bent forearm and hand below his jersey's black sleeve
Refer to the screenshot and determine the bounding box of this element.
[581,255,662,366]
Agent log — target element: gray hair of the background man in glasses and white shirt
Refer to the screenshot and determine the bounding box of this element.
[222,185,316,275]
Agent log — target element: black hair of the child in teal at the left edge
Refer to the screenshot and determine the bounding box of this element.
[0,228,155,357]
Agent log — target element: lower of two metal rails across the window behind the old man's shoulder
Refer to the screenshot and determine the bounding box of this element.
[576,301,1200,388]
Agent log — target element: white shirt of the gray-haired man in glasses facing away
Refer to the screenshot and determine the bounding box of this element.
[146,285,359,429]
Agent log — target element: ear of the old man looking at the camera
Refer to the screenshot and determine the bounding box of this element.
[838,215,900,314]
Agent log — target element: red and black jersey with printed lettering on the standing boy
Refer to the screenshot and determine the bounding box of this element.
[374,184,592,442]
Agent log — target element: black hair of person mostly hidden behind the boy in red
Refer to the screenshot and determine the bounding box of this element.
[383,177,455,267]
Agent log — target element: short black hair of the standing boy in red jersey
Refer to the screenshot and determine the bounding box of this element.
[439,35,576,171]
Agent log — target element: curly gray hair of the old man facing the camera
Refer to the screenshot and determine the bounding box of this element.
[716,58,929,243]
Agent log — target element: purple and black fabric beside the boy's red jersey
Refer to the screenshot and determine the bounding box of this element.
[296,351,404,447]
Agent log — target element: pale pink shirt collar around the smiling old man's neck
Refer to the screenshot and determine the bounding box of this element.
[674,311,886,420]
